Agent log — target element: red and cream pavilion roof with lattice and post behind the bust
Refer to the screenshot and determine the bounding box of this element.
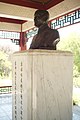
[0,0,80,50]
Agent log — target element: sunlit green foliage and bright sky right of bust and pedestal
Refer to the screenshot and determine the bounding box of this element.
[57,24,80,105]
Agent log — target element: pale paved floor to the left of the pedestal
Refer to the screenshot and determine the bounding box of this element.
[0,94,12,120]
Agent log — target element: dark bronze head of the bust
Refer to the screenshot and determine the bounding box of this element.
[34,10,49,28]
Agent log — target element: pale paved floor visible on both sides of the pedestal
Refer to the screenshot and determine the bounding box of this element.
[0,94,80,120]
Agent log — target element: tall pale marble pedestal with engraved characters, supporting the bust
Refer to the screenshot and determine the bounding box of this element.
[12,50,73,120]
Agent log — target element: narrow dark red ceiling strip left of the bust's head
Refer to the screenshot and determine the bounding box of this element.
[0,17,27,24]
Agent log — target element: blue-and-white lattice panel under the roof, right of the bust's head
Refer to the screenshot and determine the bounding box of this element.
[51,8,80,29]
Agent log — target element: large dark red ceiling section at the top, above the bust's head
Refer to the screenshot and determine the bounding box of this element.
[0,0,64,10]
